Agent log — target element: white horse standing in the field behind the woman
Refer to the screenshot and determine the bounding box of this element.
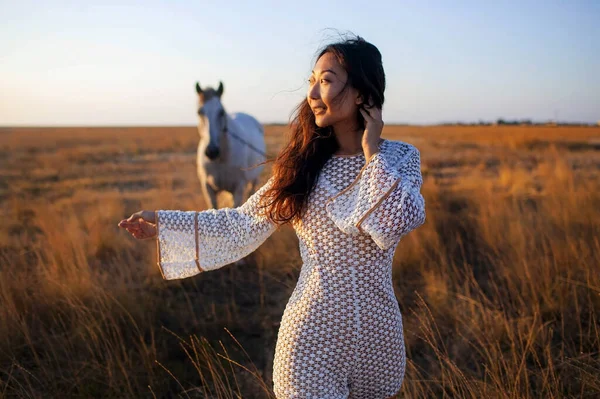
[196,82,266,208]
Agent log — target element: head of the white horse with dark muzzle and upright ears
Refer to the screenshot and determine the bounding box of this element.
[196,82,227,160]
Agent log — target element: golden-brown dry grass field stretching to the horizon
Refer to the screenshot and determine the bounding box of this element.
[0,126,600,398]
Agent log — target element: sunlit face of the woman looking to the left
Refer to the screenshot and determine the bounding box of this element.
[306,53,361,127]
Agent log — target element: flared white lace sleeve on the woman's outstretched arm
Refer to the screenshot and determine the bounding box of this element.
[156,180,277,280]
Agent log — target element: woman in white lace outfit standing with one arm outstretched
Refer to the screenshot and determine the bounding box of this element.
[119,37,425,399]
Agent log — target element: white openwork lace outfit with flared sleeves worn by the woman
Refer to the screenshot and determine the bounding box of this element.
[157,140,425,399]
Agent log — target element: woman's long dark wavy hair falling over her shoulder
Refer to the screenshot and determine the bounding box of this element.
[262,36,385,224]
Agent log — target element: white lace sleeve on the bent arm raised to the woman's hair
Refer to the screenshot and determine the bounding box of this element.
[326,144,425,250]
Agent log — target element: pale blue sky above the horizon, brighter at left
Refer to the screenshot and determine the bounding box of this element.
[0,0,600,126]
